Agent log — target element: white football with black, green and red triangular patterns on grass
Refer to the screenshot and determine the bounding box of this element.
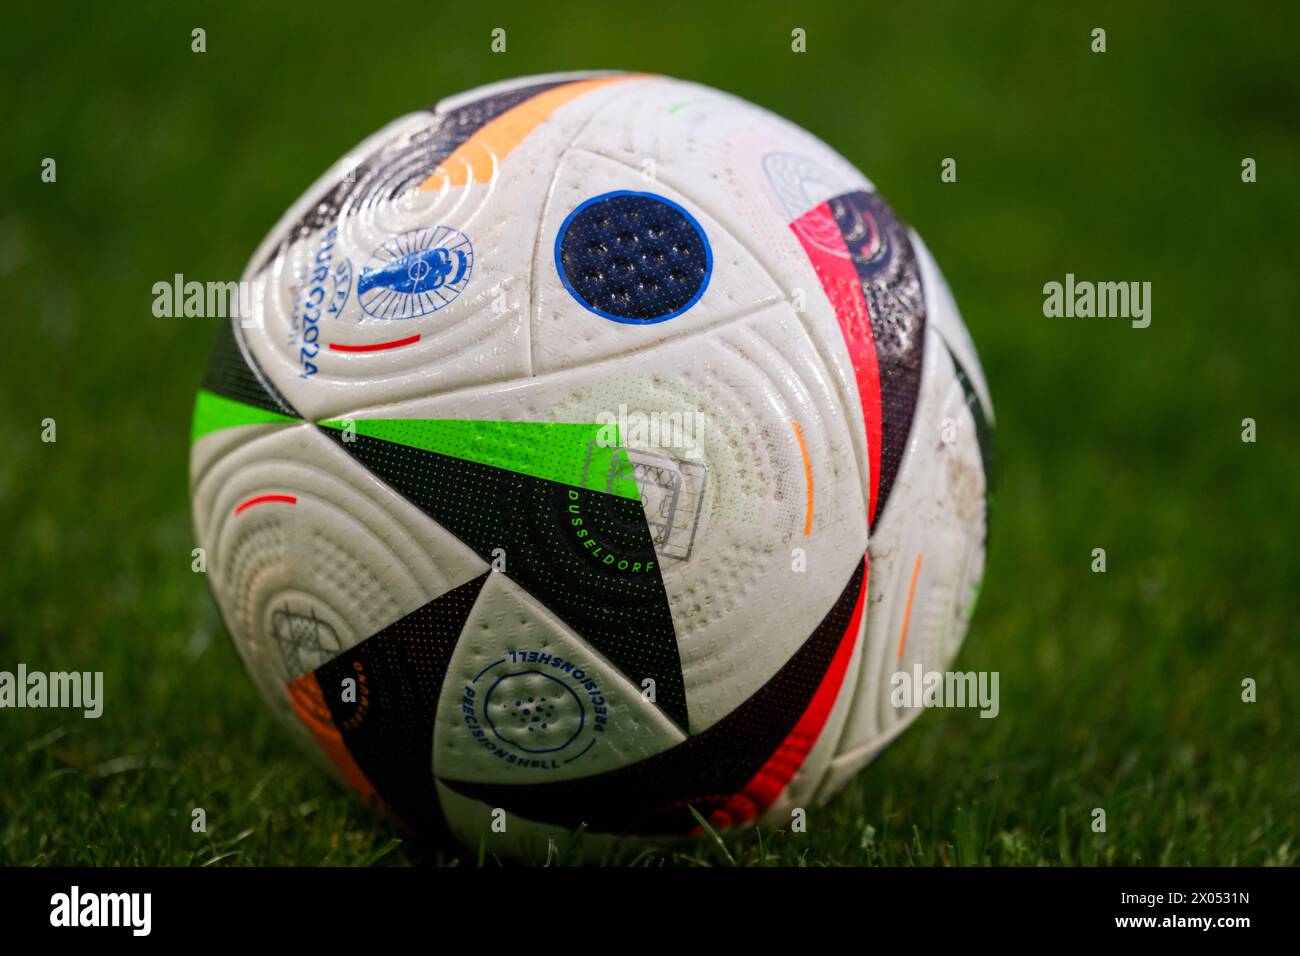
[190,73,992,856]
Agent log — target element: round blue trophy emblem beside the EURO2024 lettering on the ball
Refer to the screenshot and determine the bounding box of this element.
[356,226,475,319]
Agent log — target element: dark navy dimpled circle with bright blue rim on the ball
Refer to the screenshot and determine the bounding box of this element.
[555,190,714,325]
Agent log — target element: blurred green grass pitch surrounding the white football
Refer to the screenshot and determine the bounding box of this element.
[0,3,1300,865]
